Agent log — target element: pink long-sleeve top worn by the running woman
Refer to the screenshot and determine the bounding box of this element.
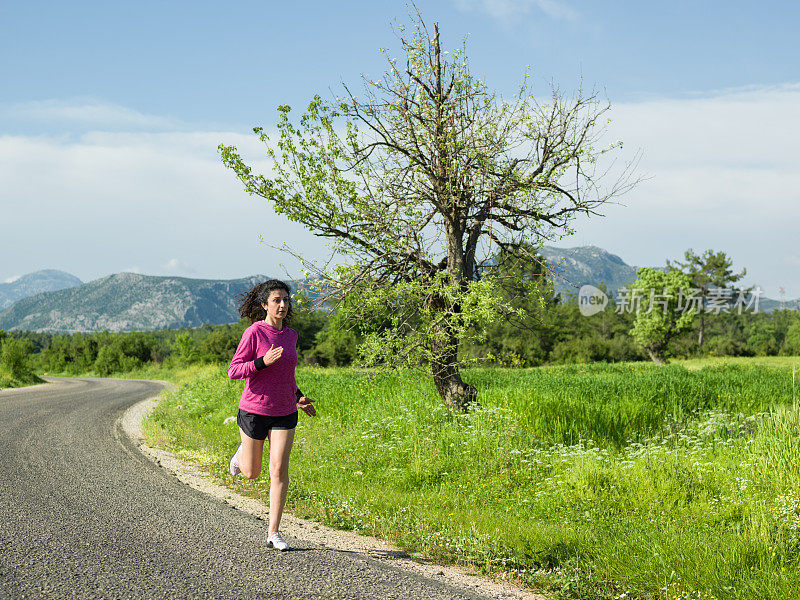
[228,321,297,417]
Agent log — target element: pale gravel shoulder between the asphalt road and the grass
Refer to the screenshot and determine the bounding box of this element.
[116,386,548,600]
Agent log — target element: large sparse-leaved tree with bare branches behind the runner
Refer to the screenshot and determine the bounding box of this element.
[220,14,634,409]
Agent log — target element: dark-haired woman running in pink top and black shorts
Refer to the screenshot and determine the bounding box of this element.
[228,279,317,550]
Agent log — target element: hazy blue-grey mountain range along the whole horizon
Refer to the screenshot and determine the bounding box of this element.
[0,245,800,333]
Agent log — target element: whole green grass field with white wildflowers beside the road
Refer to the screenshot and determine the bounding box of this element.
[145,359,800,600]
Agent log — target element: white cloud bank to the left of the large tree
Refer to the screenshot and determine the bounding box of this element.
[0,123,324,281]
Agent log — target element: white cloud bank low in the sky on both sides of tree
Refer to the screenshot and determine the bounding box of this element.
[0,84,800,297]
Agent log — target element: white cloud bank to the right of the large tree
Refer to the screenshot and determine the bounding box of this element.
[561,84,800,297]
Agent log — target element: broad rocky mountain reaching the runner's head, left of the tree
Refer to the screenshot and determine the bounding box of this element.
[0,273,267,333]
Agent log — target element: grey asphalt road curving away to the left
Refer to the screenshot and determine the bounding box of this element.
[0,378,496,600]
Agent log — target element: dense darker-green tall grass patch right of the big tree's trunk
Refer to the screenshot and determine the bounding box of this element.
[470,363,792,447]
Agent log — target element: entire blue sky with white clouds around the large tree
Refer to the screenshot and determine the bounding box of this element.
[0,0,800,297]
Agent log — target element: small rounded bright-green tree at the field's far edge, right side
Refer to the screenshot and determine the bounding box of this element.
[628,267,695,363]
